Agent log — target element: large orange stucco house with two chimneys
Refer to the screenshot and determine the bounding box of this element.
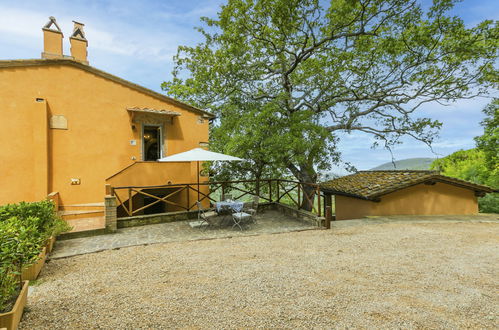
[0,17,213,214]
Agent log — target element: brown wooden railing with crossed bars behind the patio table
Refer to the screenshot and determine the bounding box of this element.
[111,179,324,216]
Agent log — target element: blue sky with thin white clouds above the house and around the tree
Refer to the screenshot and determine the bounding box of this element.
[0,0,499,171]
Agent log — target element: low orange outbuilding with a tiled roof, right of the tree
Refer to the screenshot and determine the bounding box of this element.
[320,170,495,220]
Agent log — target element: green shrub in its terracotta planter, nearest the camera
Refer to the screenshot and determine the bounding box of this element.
[0,217,41,329]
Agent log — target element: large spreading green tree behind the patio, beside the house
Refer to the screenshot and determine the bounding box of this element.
[163,0,499,210]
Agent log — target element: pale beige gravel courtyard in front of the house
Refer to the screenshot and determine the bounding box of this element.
[21,223,499,329]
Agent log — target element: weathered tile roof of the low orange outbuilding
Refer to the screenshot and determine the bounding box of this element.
[320,170,495,200]
